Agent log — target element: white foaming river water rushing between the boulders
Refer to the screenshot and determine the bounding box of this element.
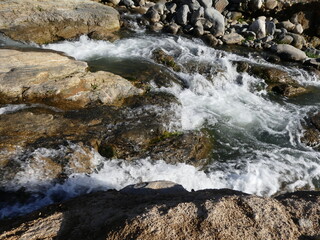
[0,34,320,219]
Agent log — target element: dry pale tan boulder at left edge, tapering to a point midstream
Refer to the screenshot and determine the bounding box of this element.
[0,49,142,109]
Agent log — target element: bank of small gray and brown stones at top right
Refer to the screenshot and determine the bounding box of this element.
[115,0,320,64]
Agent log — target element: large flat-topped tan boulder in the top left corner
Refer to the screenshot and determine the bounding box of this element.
[0,0,120,44]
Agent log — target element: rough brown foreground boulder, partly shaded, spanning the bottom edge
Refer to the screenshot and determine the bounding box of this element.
[0,186,320,240]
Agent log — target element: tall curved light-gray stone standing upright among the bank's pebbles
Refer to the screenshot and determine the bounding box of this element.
[204,7,225,37]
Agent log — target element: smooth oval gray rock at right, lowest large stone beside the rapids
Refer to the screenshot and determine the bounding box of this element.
[273,44,307,61]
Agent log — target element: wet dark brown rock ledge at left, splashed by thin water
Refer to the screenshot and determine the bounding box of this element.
[0,93,212,188]
